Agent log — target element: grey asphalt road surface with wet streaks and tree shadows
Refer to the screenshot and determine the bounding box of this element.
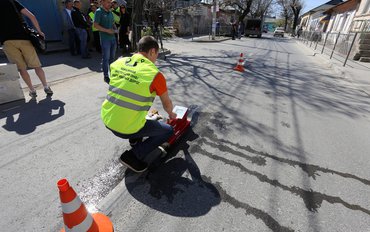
[0,33,370,232]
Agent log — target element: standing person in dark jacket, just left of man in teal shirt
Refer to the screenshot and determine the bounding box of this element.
[71,0,91,59]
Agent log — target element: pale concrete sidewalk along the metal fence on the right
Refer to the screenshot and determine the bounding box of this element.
[292,38,370,96]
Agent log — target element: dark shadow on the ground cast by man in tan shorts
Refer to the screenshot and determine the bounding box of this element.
[3,97,65,135]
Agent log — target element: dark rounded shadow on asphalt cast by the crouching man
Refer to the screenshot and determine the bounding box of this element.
[125,128,221,217]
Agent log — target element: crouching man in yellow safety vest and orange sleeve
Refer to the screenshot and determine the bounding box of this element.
[101,36,176,172]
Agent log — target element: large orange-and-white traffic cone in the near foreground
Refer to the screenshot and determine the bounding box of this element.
[57,179,113,232]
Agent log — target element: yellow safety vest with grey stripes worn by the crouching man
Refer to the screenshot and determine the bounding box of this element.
[101,54,159,134]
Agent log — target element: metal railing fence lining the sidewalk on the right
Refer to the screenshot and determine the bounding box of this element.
[298,31,370,66]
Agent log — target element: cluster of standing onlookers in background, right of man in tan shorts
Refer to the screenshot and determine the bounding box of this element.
[62,0,131,83]
